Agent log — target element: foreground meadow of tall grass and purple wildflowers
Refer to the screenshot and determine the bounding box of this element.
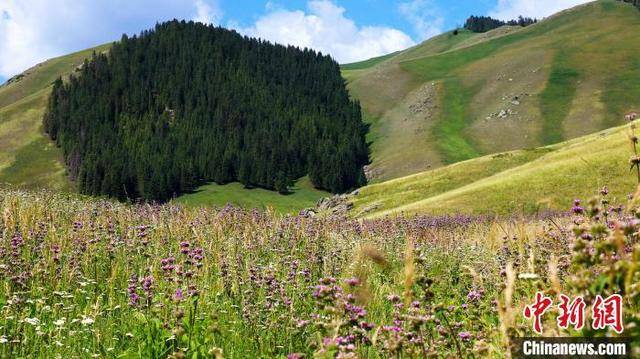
[0,120,640,358]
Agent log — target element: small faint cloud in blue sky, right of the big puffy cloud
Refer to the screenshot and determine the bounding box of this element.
[398,0,444,40]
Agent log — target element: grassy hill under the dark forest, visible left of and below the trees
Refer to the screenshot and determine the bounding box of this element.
[0,45,328,213]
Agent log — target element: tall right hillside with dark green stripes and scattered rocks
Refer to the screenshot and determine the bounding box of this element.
[343,0,640,182]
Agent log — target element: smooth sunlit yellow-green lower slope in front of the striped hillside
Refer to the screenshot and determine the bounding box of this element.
[352,119,637,217]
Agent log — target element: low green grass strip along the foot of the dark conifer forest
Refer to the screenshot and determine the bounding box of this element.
[175,177,331,214]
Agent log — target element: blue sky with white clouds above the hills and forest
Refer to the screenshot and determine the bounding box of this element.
[0,0,588,83]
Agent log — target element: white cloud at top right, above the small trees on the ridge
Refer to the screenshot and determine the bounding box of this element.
[489,0,592,20]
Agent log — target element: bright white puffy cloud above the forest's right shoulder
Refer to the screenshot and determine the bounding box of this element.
[238,0,415,63]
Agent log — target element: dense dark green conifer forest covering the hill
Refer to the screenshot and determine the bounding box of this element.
[43,20,369,201]
